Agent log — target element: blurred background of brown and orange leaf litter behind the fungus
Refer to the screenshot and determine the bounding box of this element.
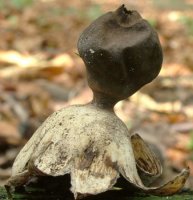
[0,0,193,191]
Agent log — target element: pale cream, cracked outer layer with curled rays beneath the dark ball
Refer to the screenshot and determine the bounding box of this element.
[7,104,189,198]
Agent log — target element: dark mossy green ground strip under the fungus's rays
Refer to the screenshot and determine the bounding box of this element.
[0,187,193,200]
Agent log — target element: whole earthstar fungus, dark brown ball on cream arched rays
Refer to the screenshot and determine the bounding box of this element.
[6,5,189,198]
